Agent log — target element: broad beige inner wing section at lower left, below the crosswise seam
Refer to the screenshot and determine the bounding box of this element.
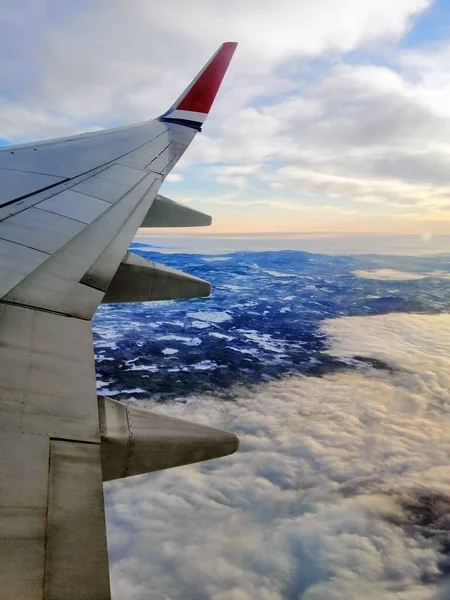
[0,304,109,600]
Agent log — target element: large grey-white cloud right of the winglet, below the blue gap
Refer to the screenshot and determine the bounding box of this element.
[178,54,450,213]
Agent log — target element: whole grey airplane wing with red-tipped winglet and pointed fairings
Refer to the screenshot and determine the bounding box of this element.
[0,43,238,600]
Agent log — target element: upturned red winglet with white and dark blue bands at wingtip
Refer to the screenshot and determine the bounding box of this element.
[159,42,237,130]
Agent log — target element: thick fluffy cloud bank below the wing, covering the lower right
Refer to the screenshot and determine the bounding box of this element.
[106,314,450,600]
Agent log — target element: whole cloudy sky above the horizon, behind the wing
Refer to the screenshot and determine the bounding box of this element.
[0,0,450,236]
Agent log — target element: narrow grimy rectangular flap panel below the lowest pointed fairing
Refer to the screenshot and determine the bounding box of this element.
[44,439,110,600]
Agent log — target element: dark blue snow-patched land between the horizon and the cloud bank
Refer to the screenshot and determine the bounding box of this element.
[94,244,450,402]
